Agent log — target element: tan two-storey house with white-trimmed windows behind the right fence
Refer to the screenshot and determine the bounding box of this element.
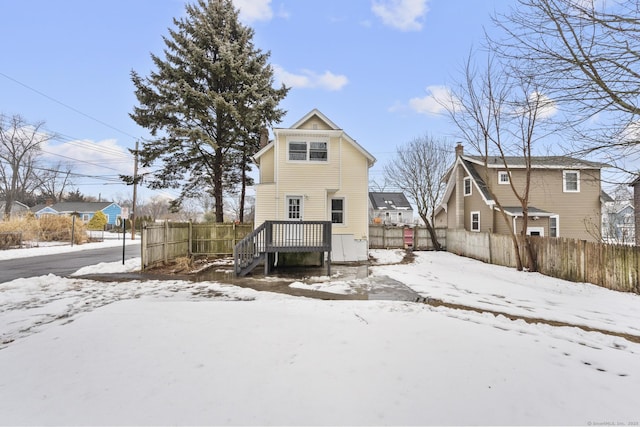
[435,144,607,241]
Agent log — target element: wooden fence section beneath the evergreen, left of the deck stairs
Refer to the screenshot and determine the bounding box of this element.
[141,221,253,270]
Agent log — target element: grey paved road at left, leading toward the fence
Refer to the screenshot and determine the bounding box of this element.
[0,245,140,283]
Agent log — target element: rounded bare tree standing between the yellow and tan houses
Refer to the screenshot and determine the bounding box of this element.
[384,135,451,250]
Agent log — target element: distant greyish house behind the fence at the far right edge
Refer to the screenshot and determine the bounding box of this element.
[602,191,635,244]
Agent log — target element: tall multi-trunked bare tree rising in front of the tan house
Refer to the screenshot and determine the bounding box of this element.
[441,55,552,271]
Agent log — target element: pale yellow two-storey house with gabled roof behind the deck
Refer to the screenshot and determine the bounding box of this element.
[254,109,375,261]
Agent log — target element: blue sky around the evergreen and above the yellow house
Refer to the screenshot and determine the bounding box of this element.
[0,0,512,205]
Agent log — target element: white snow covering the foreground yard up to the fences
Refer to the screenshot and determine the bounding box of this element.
[0,249,640,426]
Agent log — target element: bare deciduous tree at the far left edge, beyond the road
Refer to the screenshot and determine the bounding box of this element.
[0,115,50,218]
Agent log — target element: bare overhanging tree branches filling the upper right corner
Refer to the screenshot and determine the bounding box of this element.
[490,0,640,163]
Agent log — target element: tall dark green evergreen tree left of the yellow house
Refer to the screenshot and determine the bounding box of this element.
[129,0,288,222]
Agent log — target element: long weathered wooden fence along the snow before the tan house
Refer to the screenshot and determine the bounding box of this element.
[447,230,640,294]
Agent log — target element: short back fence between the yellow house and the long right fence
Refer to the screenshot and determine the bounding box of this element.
[369,224,447,251]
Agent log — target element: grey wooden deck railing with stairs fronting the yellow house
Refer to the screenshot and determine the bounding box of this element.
[233,221,331,276]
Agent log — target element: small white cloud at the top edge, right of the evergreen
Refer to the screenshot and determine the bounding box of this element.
[371,0,429,31]
